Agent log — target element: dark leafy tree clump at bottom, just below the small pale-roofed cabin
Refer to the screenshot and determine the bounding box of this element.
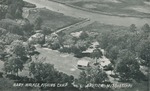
[76,67,108,88]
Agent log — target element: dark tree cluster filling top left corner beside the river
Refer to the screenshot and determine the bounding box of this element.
[0,0,36,19]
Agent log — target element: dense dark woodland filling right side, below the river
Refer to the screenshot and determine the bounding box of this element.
[97,24,150,81]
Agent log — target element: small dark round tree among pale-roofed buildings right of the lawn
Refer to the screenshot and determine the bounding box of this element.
[91,48,103,64]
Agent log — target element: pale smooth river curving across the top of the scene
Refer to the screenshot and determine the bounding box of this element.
[24,0,150,27]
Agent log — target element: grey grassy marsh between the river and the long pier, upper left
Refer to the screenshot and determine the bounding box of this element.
[27,8,82,30]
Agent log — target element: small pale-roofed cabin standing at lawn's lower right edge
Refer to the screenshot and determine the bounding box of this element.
[77,60,90,69]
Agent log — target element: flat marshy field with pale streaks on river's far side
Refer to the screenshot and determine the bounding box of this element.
[49,0,150,17]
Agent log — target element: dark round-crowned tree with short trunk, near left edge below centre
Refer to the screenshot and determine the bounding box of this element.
[4,55,23,76]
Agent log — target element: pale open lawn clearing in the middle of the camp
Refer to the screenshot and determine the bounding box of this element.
[33,48,92,78]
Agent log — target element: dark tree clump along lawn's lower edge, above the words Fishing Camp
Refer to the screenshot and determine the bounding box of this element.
[29,59,74,84]
